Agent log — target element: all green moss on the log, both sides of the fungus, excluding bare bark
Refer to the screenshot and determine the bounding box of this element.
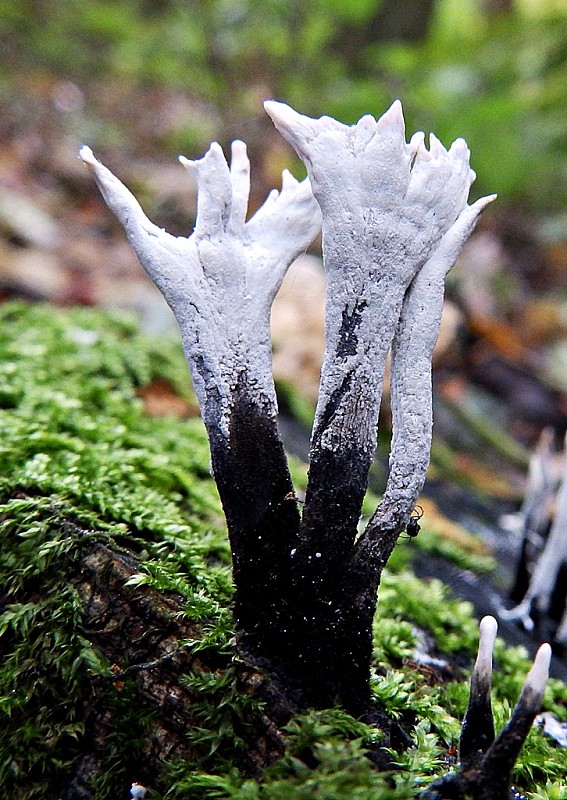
[0,304,567,800]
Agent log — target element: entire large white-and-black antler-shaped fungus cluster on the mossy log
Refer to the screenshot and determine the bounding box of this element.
[81,101,493,714]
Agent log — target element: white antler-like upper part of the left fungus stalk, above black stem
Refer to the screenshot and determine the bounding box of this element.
[80,141,320,436]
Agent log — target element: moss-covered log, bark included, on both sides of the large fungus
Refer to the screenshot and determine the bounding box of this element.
[0,304,567,800]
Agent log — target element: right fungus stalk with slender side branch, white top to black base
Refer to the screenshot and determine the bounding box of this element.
[265,101,494,709]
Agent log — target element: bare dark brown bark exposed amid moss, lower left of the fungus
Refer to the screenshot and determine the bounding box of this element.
[62,541,294,800]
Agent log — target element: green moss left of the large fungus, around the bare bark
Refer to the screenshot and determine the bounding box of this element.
[0,304,230,798]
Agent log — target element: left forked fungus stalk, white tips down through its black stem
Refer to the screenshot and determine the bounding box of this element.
[80,141,321,659]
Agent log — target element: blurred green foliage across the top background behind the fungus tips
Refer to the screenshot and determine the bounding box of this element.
[0,0,567,210]
